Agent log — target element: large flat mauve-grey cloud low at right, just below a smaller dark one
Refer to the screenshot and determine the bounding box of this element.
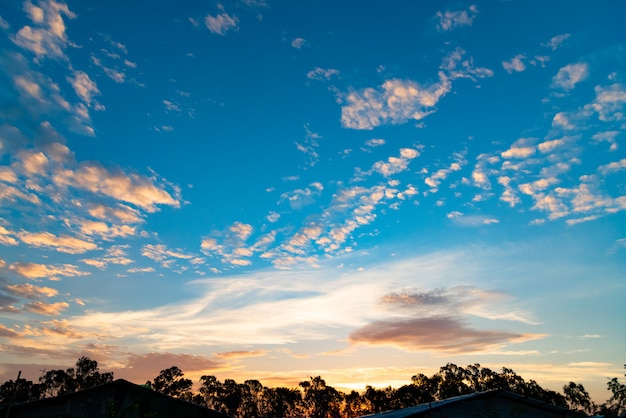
[349,317,542,354]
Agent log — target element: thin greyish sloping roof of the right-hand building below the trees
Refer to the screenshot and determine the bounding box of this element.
[364,389,568,418]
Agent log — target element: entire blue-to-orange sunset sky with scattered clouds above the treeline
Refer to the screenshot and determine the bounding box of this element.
[0,0,626,402]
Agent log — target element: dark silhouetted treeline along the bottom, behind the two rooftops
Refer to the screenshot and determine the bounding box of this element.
[0,357,626,418]
